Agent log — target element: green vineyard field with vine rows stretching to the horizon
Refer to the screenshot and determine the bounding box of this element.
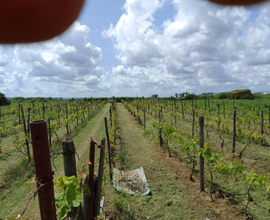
[0,95,270,220]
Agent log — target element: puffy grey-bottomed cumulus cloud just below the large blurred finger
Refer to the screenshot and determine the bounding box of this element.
[15,22,102,83]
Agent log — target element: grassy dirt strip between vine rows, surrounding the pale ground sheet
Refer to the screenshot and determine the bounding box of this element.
[104,104,245,220]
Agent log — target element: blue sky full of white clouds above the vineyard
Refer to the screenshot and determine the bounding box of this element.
[0,0,270,98]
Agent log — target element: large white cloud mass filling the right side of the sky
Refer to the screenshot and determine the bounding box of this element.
[105,0,270,96]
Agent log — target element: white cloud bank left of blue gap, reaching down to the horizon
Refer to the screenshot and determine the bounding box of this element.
[0,22,109,96]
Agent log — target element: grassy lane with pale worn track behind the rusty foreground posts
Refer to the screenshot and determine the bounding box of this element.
[0,104,110,220]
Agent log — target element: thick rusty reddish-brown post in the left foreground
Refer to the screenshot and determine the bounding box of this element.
[30,120,57,220]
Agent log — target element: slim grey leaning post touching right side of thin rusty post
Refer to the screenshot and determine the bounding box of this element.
[94,138,105,217]
